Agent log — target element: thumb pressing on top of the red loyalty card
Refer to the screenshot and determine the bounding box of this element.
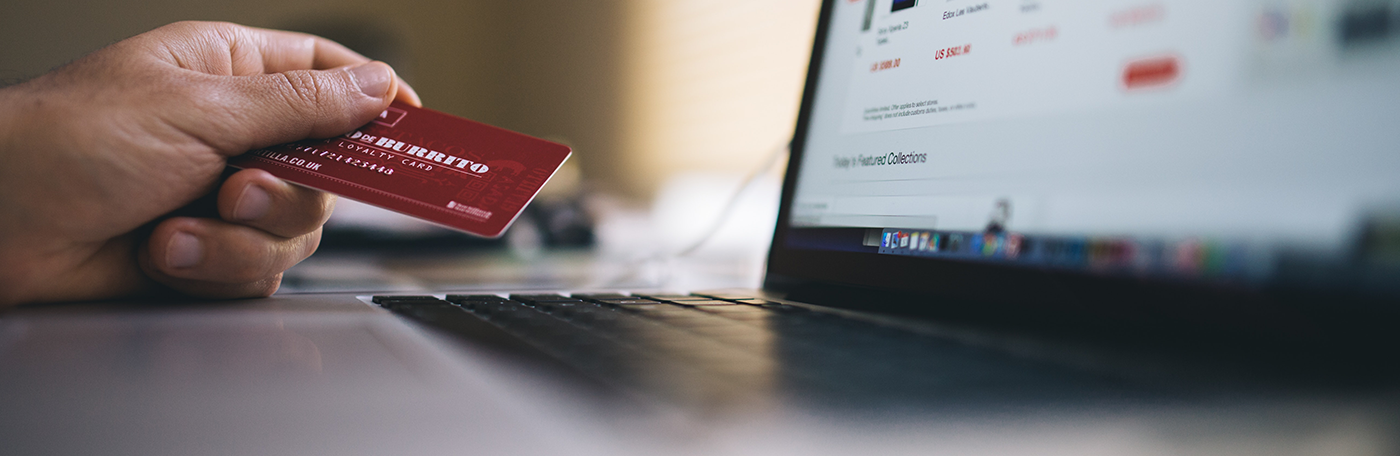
[196,62,398,155]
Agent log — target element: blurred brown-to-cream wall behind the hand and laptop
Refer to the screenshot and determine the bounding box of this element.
[0,0,818,204]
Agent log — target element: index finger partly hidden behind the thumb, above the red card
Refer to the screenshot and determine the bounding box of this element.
[243,27,423,108]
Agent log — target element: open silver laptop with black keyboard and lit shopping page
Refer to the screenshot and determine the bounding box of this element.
[0,0,1400,455]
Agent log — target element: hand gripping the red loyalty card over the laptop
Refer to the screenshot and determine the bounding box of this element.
[0,22,421,306]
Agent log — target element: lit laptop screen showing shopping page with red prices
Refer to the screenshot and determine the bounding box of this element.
[777,0,1400,290]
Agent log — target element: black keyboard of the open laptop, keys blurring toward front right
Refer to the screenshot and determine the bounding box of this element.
[372,294,1121,406]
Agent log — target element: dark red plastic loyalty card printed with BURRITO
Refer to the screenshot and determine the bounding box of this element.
[228,102,571,238]
